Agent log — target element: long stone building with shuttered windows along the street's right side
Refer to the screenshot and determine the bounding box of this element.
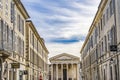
[81,0,120,80]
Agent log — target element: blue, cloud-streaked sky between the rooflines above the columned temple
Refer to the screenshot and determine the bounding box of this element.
[21,0,100,58]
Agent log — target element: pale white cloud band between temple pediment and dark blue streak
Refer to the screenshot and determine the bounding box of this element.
[47,41,83,57]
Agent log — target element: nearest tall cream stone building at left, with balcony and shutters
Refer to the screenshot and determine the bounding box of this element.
[0,0,29,80]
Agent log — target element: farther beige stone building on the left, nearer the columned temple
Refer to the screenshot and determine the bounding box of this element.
[26,20,49,80]
